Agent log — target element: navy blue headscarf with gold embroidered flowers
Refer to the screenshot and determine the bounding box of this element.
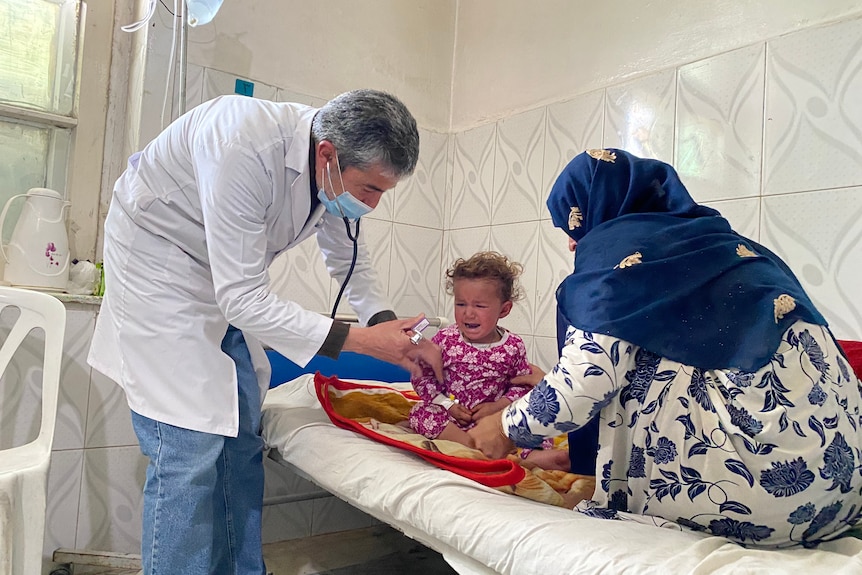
[547,149,826,371]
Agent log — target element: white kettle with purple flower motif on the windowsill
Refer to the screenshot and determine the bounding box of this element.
[0,188,69,291]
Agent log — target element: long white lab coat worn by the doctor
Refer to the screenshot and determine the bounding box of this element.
[87,96,392,437]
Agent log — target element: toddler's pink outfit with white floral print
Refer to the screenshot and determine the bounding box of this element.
[410,325,530,439]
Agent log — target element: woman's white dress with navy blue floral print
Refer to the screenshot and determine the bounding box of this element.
[503,321,862,547]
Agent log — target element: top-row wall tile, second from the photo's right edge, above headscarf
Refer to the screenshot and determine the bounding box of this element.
[674,44,766,202]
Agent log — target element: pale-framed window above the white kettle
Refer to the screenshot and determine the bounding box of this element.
[0,0,81,241]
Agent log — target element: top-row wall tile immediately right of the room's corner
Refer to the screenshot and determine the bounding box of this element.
[447,124,496,228]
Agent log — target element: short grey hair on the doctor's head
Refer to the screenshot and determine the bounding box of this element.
[311,90,419,180]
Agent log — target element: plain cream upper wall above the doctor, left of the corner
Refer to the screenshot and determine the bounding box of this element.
[189,0,455,131]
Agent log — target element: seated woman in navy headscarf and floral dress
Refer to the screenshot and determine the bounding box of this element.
[470,149,862,547]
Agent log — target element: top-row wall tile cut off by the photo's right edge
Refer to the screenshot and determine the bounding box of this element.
[765,19,862,194]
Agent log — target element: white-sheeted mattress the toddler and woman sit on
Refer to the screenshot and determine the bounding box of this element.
[263,375,862,575]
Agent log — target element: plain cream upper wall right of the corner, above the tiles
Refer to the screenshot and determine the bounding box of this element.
[451,0,862,131]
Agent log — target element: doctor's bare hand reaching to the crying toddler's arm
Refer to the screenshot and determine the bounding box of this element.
[344,315,443,382]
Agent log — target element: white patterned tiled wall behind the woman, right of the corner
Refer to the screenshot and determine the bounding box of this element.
[446,14,862,369]
